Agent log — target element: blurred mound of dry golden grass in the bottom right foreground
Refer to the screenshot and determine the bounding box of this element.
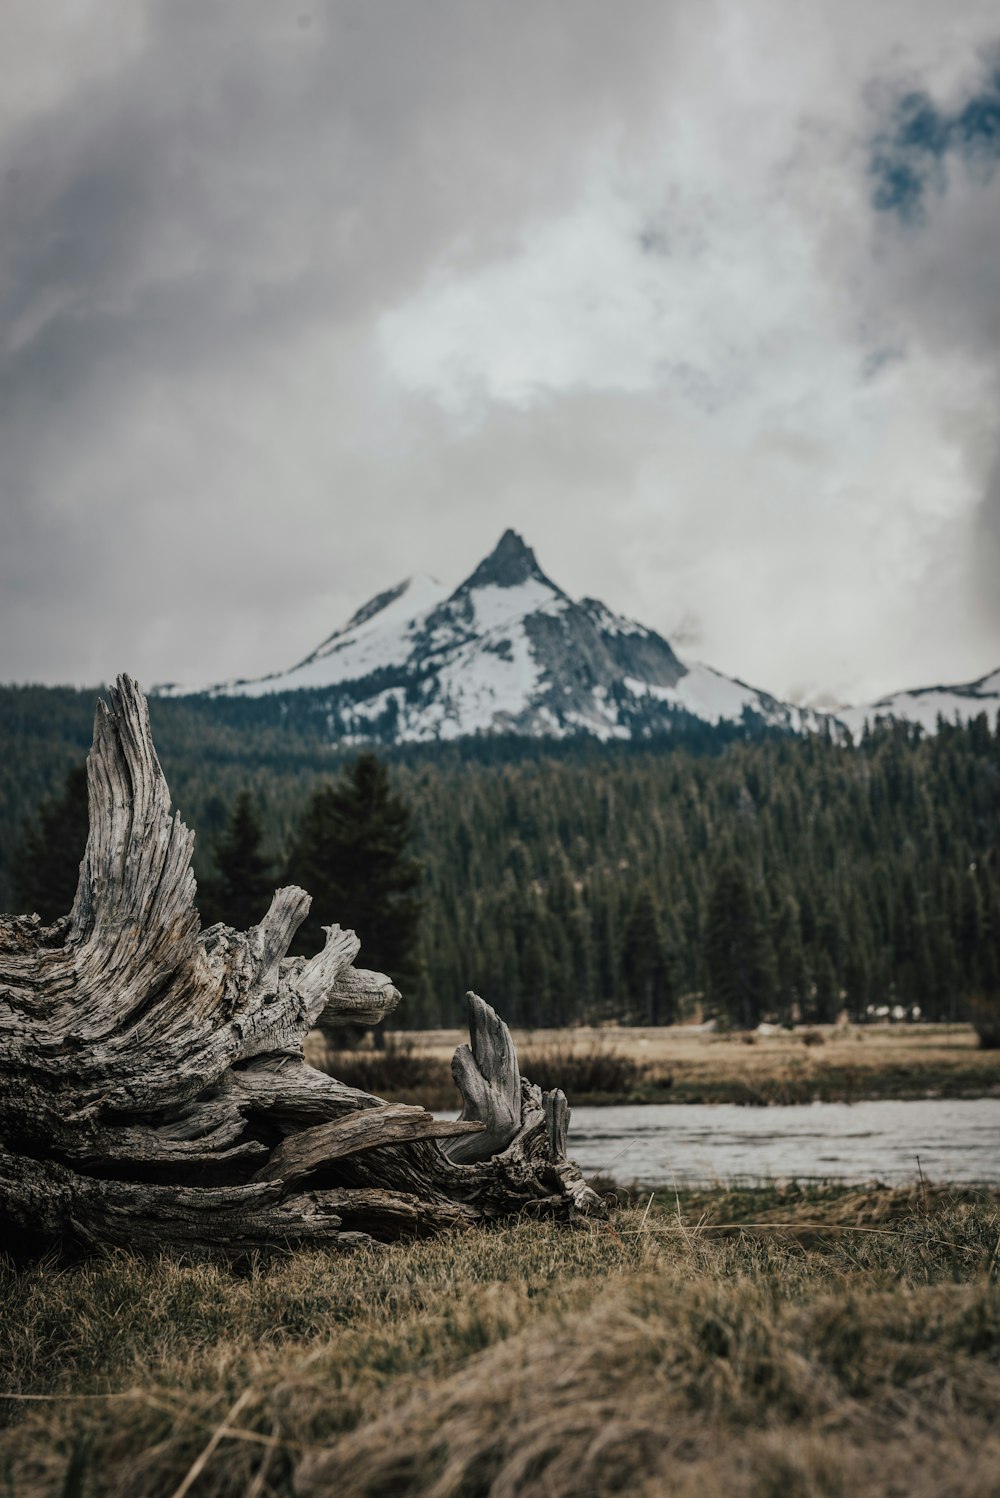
[296,1278,1000,1498]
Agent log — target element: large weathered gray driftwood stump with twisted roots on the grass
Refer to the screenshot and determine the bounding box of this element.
[0,677,600,1249]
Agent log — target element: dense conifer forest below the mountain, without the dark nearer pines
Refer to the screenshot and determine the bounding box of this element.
[0,688,1000,1026]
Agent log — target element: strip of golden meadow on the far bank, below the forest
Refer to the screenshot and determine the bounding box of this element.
[307,1025,1000,1112]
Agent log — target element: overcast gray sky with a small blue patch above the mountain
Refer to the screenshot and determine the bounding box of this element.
[0,0,1000,704]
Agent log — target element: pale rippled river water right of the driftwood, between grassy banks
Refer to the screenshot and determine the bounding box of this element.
[569,1098,1000,1185]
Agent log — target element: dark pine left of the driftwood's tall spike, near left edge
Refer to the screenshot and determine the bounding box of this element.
[15,764,88,926]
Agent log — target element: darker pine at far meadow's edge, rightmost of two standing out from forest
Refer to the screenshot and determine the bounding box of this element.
[705,860,774,1029]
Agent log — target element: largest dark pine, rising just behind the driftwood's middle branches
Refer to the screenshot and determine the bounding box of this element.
[287,752,422,986]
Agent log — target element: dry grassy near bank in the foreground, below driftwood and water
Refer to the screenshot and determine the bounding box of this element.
[0,1186,1000,1498]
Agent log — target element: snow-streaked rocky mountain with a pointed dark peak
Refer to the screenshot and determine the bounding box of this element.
[162,530,828,743]
